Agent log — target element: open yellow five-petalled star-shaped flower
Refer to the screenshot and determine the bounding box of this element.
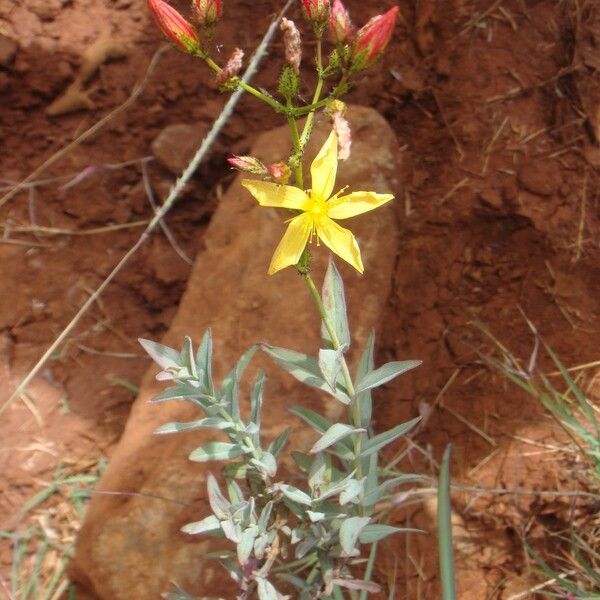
[242,131,394,275]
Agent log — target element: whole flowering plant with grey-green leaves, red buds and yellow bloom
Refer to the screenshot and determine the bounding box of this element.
[141,0,420,600]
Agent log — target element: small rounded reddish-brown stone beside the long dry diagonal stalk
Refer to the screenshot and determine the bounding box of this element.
[152,123,207,175]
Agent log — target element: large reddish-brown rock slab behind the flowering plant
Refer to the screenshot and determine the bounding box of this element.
[71,107,399,600]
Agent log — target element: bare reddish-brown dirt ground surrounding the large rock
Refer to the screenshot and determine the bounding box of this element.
[0,0,600,600]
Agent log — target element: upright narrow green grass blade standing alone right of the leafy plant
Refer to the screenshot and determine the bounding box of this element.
[438,444,456,600]
